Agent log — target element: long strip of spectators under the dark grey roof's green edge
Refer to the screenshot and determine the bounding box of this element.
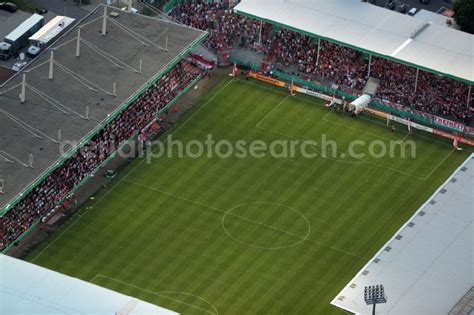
[0,61,201,251]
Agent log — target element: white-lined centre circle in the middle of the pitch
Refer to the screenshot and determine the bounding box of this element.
[221,202,311,249]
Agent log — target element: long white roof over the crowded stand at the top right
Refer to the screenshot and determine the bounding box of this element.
[235,0,474,84]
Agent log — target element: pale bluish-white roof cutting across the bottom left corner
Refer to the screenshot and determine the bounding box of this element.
[0,254,177,315]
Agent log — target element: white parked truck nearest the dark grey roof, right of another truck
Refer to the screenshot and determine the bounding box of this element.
[26,16,75,58]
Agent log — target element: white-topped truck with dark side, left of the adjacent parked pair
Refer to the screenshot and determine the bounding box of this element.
[0,13,44,60]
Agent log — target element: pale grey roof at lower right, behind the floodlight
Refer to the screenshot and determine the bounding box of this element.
[331,154,474,315]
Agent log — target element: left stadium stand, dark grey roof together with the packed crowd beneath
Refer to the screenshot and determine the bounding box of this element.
[0,6,206,251]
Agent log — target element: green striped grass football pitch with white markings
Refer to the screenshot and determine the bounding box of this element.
[28,79,467,315]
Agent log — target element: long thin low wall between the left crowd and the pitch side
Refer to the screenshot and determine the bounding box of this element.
[2,75,202,254]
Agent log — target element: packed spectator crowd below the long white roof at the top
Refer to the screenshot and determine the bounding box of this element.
[170,0,474,124]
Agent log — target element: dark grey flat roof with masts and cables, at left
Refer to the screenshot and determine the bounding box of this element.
[0,6,206,214]
